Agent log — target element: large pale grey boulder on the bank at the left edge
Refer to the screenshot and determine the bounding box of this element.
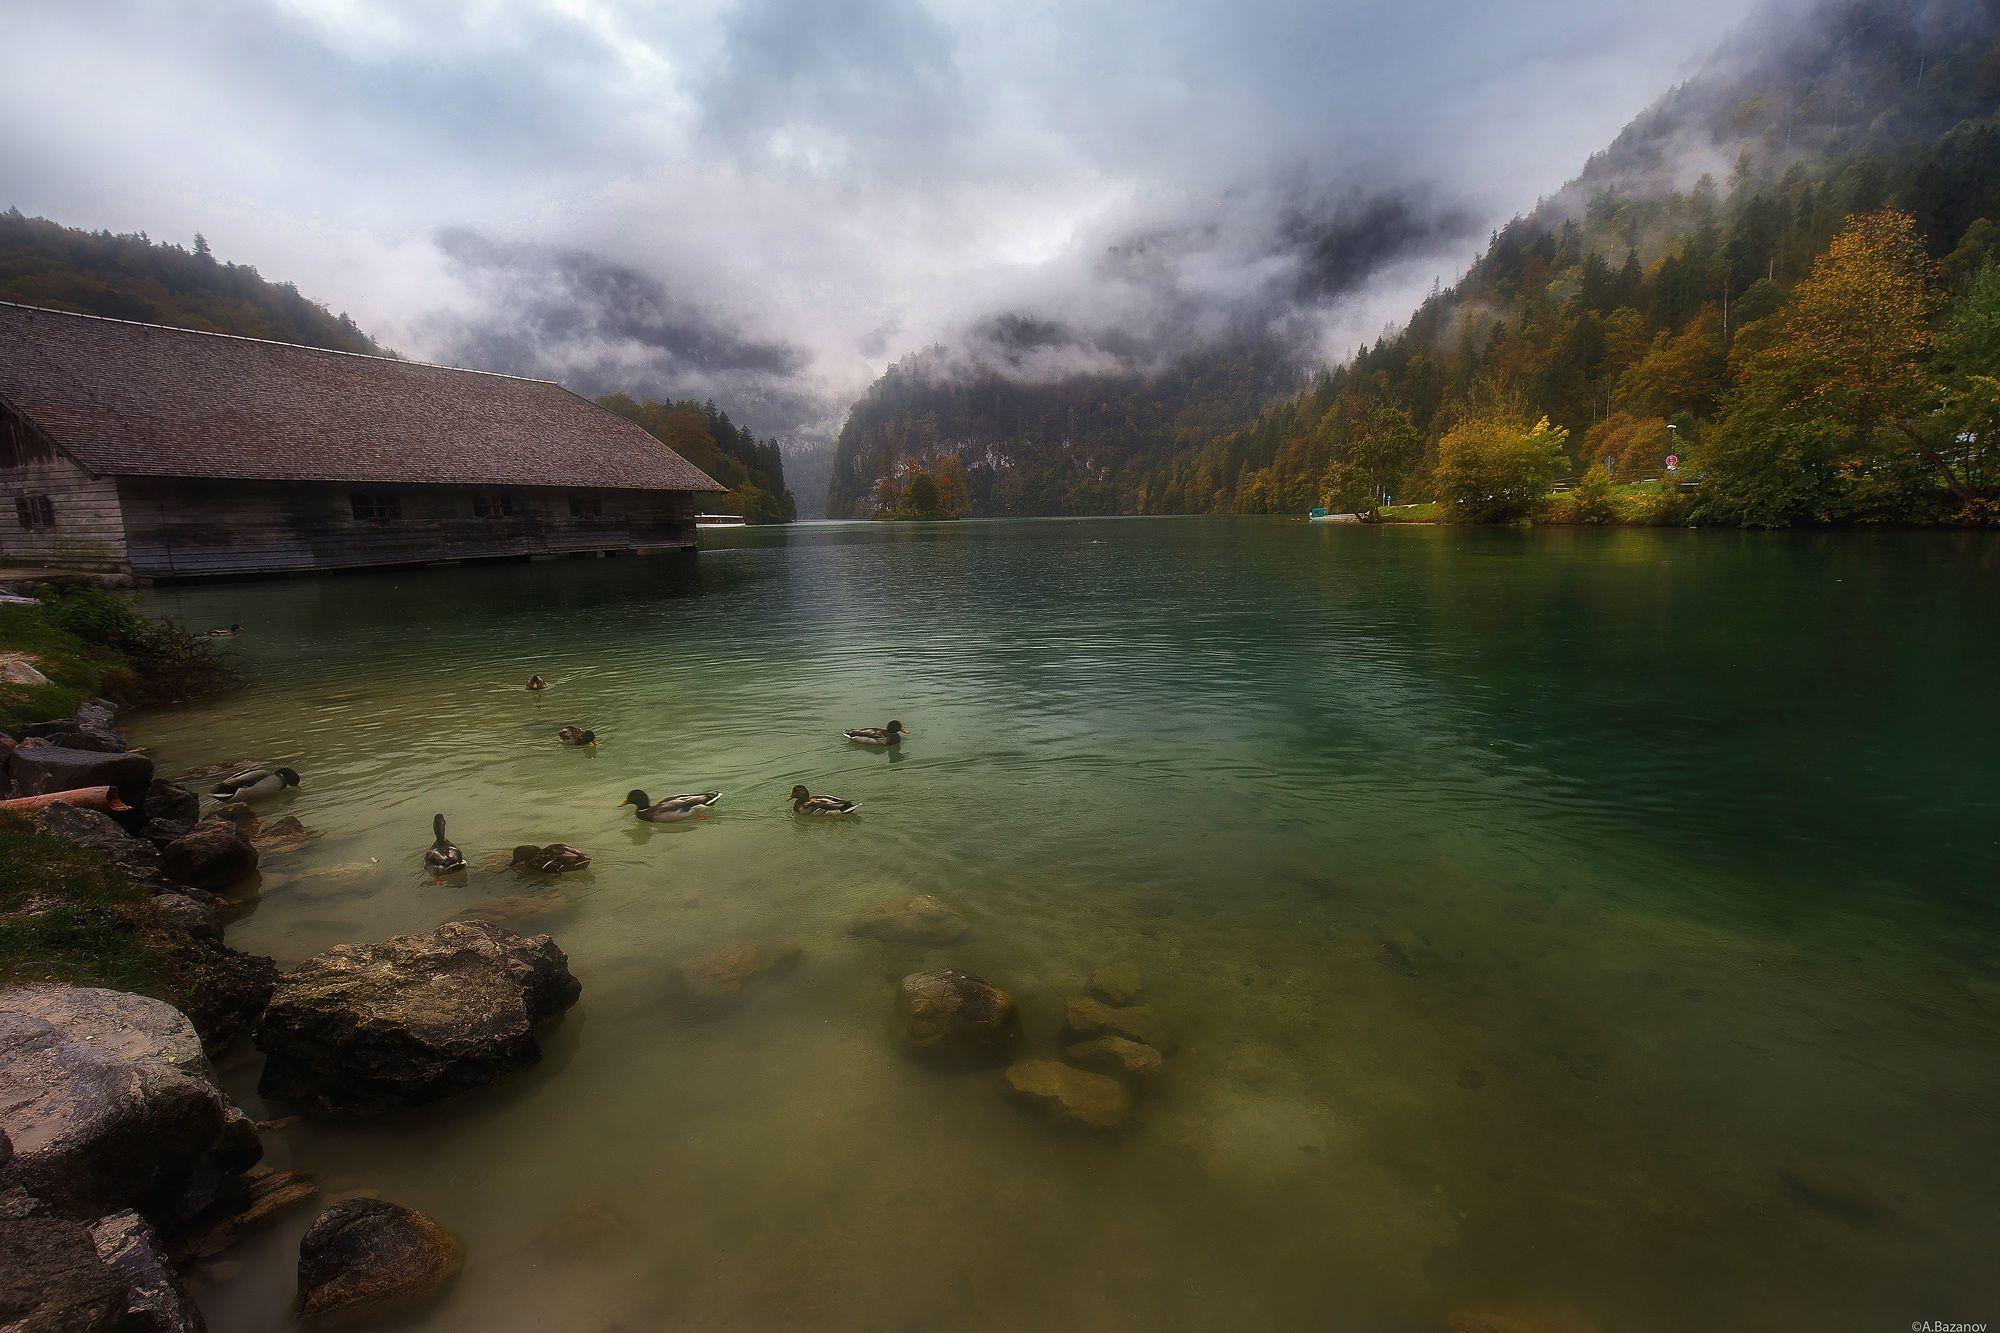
[0,985,262,1225]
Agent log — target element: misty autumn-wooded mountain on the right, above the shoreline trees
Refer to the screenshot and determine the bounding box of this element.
[828,0,2000,516]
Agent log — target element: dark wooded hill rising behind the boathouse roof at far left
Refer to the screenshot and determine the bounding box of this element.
[0,208,382,356]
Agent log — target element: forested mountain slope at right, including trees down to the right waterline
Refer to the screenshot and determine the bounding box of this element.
[832,0,2000,522]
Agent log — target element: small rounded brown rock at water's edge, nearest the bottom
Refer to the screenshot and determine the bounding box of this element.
[298,1199,464,1319]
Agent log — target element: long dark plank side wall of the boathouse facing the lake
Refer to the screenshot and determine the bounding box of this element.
[118,476,694,580]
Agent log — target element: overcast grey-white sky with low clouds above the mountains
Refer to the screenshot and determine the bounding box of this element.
[0,0,1752,438]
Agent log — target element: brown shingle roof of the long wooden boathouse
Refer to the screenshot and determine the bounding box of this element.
[0,302,722,490]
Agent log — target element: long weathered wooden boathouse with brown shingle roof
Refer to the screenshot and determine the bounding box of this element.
[0,302,722,580]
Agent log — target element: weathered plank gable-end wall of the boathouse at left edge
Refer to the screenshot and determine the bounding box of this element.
[0,404,126,570]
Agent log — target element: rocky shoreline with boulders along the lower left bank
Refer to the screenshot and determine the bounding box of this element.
[0,699,580,1333]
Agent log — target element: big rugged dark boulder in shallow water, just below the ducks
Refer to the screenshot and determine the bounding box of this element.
[256,921,582,1113]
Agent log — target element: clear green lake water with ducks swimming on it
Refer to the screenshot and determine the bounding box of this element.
[132,520,2000,1333]
